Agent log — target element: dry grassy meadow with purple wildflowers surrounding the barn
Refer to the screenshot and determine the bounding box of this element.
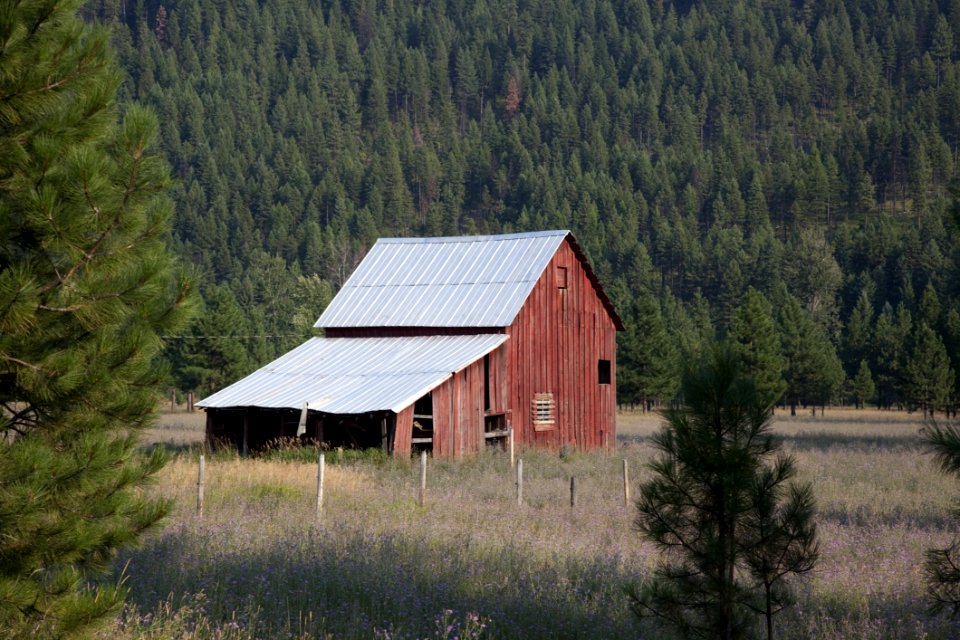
[104,410,960,639]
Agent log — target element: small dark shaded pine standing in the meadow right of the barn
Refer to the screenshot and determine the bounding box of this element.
[631,344,817,639]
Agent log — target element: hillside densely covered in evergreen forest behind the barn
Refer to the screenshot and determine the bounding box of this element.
[94,0,960,409]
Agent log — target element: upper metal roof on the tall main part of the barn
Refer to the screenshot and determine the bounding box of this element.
[314,231,568,328]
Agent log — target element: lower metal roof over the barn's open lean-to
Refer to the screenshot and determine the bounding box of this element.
[197,334,507,414]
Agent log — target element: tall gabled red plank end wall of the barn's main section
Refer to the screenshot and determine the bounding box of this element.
[506,242,616,449]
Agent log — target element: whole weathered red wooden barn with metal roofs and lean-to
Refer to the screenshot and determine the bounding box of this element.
[198,231,623,457]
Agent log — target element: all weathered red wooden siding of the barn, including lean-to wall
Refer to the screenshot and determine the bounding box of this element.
[326,235,617,458]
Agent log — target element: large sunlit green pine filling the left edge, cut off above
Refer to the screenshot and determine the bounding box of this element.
[0,0,191,638]
